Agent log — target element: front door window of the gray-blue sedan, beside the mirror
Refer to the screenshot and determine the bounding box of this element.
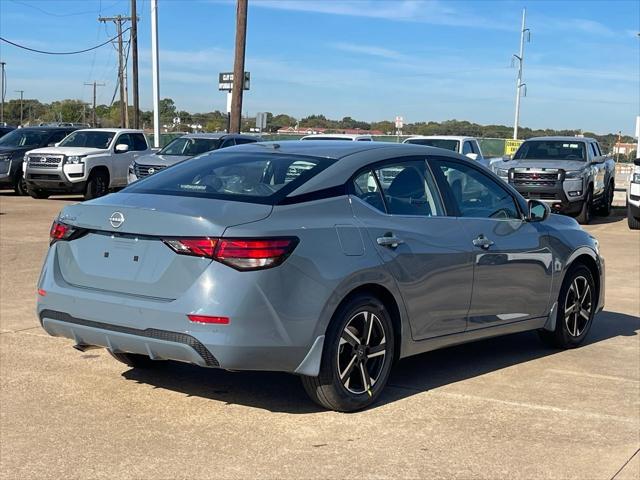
[433,160,520,219]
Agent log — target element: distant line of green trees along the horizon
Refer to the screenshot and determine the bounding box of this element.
[4,98,634,158]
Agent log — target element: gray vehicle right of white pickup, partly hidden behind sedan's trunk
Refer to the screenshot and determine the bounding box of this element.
[128,133,260,183]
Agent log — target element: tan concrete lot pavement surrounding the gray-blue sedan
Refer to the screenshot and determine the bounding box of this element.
[0,192,640,480]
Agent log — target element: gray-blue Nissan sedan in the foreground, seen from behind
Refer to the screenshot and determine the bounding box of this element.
[37,141,605,411]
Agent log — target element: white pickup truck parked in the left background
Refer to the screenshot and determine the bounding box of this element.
[25,128,150,200]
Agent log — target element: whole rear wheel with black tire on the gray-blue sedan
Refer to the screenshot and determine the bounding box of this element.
[301,295,395,412]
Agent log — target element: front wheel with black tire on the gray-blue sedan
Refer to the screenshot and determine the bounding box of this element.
[538,265,598,348]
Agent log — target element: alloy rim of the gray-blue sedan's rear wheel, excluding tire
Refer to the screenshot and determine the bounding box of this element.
[337,310,387,395]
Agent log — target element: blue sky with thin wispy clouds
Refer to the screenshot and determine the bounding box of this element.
[0,0,640,134]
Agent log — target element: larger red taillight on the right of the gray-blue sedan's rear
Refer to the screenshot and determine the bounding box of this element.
[164,237,298,270]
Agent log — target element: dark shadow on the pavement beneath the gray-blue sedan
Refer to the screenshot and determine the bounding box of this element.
[122,311,640,414]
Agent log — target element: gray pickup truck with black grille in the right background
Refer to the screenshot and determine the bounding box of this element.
[492,137,616,224]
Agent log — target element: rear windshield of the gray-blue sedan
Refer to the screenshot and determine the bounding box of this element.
[125,149,334,205]
